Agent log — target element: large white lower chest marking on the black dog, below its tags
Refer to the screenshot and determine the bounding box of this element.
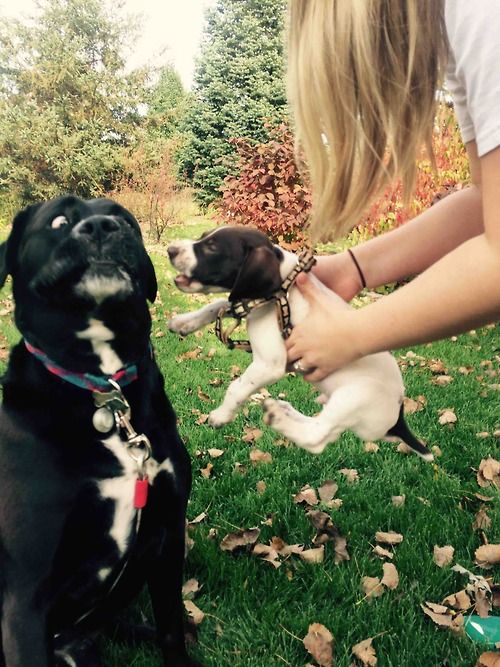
[98,435,174,556]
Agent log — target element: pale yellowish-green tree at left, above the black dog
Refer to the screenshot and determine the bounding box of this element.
[0,0,144,202]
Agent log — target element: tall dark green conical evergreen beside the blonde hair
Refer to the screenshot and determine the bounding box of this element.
[178,0,286,203]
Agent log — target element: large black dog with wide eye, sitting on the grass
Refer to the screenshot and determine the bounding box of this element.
[0,196,194,667]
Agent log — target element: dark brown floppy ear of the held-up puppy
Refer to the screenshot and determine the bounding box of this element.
[229,246,283,301]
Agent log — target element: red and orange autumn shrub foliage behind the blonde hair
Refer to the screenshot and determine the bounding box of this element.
[219,104,470,249]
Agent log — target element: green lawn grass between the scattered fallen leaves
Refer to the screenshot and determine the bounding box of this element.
[0,230,500,667]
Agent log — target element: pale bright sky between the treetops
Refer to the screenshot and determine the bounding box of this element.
[0,0,215,88]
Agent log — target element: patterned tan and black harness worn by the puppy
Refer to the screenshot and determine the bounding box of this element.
[215,250,316,352]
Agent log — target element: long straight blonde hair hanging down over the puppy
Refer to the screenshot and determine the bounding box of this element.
[288,0,447,239]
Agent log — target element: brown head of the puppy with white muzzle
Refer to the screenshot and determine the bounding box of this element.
[168,225,283,301]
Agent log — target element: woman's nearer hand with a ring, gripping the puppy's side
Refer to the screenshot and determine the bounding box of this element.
[285,273,363,382]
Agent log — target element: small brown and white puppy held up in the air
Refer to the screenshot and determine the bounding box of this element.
[168,226,433,461]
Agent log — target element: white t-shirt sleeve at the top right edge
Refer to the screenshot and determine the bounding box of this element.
[445,0,500,157]
